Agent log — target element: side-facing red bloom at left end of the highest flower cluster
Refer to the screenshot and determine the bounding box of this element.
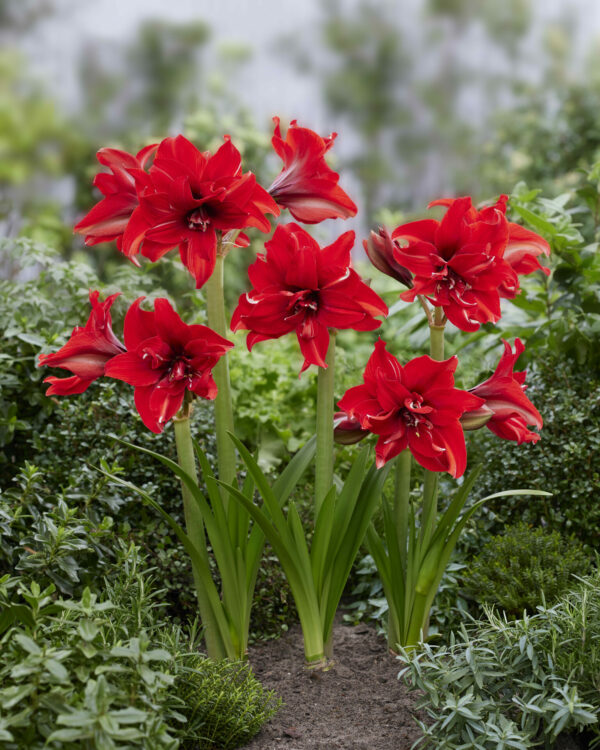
[74,144,158,250]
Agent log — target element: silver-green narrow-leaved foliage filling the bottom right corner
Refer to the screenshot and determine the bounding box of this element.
[399,572,600,750]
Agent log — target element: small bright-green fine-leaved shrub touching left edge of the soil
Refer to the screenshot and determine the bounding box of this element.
[173,654,281,750]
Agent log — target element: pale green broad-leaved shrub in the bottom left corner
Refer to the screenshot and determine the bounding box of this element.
[0,549,183,750]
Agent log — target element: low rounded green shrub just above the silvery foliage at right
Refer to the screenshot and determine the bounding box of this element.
[464,522,591,617]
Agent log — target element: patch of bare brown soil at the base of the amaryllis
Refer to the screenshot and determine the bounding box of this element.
[246,622,421,750]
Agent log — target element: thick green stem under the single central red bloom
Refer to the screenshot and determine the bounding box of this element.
[315,332,335,521]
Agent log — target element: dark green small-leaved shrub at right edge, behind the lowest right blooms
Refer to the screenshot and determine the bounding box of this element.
[468,355,600,551]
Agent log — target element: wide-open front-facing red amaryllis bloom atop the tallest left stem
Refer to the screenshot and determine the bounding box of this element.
[122,135,279,288]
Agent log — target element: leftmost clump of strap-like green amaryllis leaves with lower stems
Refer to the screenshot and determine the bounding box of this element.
[101,434,318,659]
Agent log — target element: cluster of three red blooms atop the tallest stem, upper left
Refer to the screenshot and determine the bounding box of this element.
[75,118,356,288]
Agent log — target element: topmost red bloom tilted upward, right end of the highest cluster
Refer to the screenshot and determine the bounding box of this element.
[269,117,356,224]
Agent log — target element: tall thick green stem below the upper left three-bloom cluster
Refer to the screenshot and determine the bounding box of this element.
[205,251,235,494]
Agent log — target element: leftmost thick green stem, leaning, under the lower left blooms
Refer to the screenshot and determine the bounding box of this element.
[173,414,227,659]
